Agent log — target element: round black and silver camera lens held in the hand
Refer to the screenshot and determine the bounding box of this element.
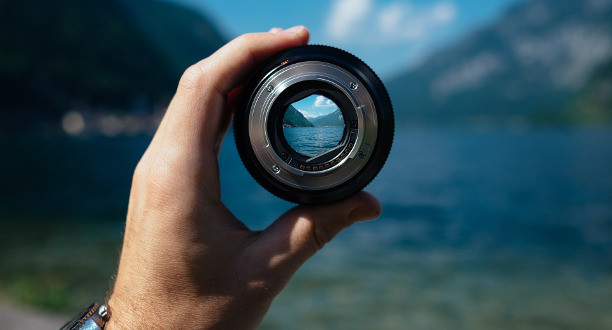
[234,46,393,204]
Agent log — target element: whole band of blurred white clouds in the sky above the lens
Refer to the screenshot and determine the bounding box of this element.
[327,0,457,45]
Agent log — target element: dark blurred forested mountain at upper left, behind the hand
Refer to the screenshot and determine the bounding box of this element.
[0,0,225,130]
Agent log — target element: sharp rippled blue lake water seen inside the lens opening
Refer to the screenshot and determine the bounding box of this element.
[283,126,344,157]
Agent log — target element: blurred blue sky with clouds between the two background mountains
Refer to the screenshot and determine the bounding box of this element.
[166,0,521,79]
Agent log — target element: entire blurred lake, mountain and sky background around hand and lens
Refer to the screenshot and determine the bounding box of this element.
[0,0,612,329]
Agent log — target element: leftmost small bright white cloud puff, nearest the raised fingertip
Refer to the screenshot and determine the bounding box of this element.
[327,0,372,39]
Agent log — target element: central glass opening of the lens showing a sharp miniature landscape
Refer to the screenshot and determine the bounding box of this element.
[283,94,344,157]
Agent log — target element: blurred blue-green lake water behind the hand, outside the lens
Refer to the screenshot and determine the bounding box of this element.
[0,128,612,329]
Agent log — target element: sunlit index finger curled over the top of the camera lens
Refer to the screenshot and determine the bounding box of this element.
[164,26,309,151]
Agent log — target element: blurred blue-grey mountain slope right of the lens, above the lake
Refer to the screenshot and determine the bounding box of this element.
[387,0,612,123]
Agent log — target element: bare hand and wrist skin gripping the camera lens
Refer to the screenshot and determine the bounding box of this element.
[107,26,381,329]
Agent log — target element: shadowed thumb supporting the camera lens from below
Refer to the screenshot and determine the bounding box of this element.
[252,192,381,276]
